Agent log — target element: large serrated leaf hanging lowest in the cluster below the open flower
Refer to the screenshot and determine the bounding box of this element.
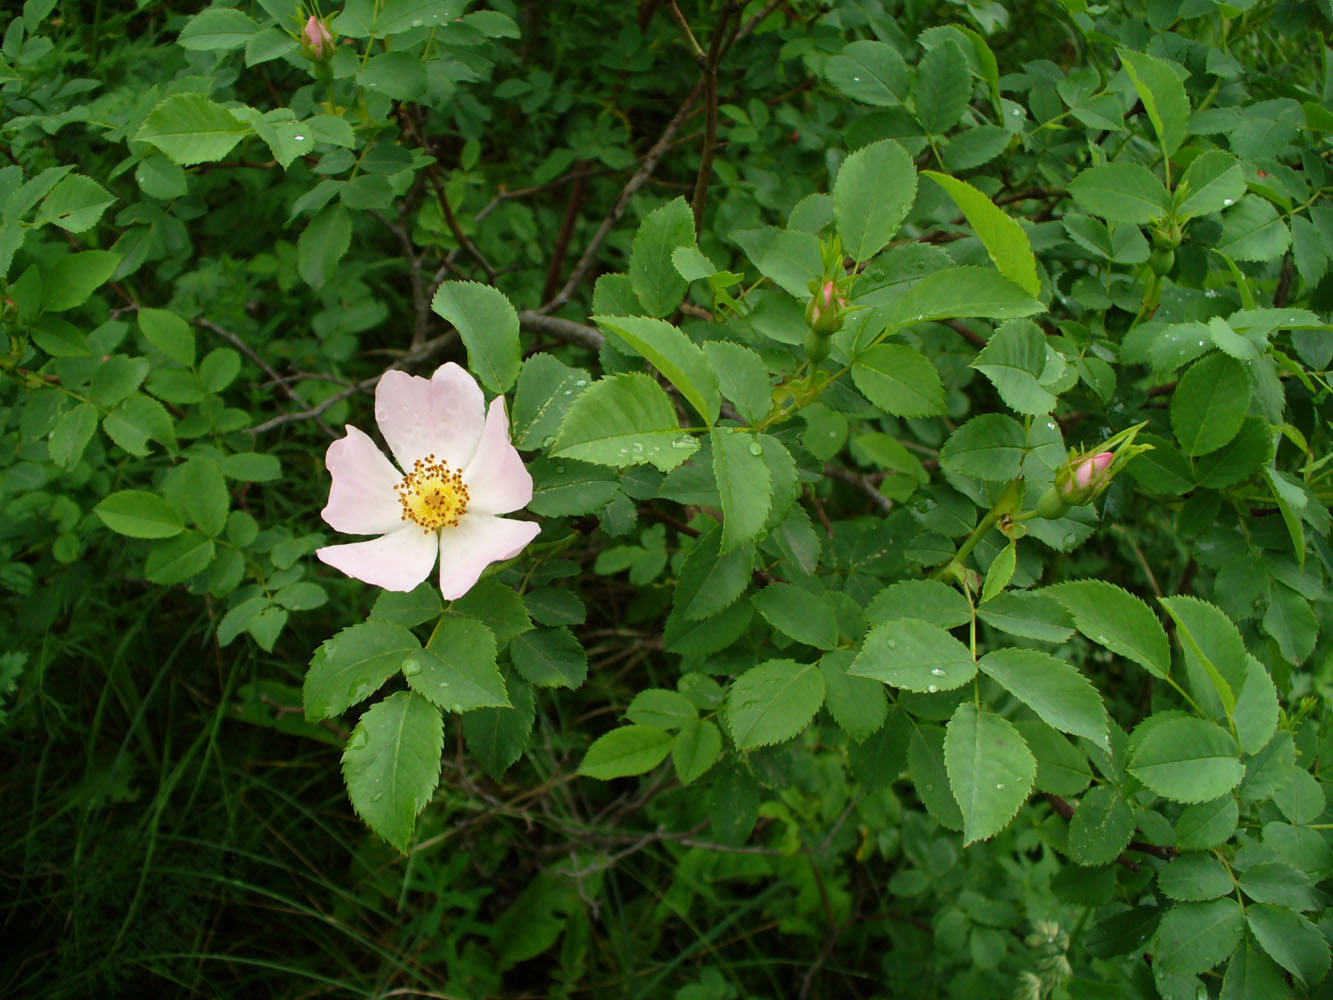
[343,691,444,853]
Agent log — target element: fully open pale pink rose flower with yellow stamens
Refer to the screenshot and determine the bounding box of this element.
[315,361,541,600]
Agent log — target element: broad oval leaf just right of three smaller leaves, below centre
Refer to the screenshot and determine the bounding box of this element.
[724,660,824,749]
